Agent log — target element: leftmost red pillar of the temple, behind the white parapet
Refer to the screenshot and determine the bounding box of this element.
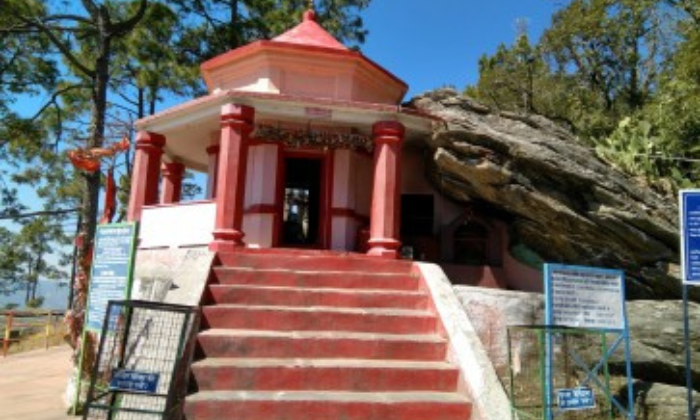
[127,131,165,222]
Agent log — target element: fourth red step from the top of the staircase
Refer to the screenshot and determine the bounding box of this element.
[202,304,437,334]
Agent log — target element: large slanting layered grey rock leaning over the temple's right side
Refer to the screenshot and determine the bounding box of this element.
[409,89,680,299]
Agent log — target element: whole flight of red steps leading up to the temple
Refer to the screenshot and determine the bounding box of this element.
[185,251,471,420]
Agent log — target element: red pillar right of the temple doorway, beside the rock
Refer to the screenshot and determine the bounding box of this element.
[367,121,405,258]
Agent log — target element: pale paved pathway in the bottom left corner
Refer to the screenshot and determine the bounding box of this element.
[0,346,79,420]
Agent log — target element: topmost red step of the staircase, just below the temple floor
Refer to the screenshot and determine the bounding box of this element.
[217,249,412,274]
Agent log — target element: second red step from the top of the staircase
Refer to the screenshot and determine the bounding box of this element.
[214,267,419,291]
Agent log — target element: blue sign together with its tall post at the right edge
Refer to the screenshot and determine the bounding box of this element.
[678,190,700,420]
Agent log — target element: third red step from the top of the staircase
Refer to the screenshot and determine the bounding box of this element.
[209,284,428,309]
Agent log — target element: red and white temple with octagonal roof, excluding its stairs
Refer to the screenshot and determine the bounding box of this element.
[128,10,541,289]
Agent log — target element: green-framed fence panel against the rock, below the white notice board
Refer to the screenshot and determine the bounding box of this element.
[506,326,627,420]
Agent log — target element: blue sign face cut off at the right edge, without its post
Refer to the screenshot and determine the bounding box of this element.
[679,190,700,284]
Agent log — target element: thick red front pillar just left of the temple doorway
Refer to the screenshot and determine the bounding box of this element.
[209,104,255,252]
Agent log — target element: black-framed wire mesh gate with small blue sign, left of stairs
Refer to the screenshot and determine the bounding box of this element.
[83,301,197,420]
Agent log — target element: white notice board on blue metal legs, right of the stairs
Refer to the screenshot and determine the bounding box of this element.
[544,264,634,420]
